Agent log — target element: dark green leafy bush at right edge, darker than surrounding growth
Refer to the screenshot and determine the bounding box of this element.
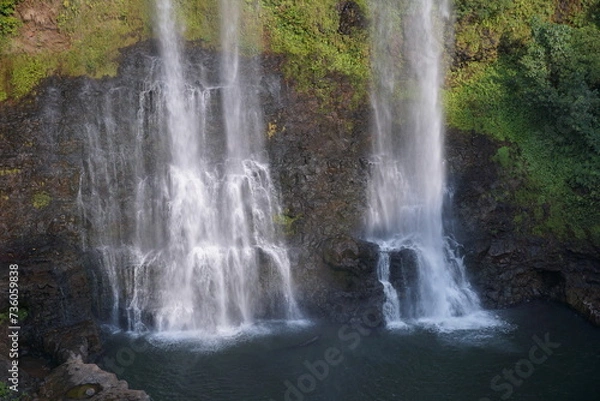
[519,18,600,205]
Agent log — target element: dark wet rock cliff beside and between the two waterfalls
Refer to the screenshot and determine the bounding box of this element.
[0,37,600,396]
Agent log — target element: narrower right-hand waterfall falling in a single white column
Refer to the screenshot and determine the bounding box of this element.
[366,0,480,324]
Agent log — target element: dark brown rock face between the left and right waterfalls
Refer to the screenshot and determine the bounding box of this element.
[265,60,382,321]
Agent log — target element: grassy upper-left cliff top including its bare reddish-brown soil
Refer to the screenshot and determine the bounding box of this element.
[0,0,150,100]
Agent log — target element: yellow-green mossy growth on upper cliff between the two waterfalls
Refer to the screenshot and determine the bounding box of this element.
[262,0,370,104]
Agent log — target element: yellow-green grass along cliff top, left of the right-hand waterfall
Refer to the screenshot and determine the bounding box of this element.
[0,0,370,105]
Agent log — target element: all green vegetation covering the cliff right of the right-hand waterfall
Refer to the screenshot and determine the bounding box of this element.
[445,0,600,242]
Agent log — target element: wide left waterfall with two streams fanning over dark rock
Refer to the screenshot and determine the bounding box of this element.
[80,0,299,333]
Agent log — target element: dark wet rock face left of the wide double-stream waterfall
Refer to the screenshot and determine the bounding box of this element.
[0,72,98,355]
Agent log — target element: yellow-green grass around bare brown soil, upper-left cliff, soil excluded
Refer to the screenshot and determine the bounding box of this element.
[0,0,150,101]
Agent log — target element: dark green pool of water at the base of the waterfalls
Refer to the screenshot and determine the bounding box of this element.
[101,303,600,401]
